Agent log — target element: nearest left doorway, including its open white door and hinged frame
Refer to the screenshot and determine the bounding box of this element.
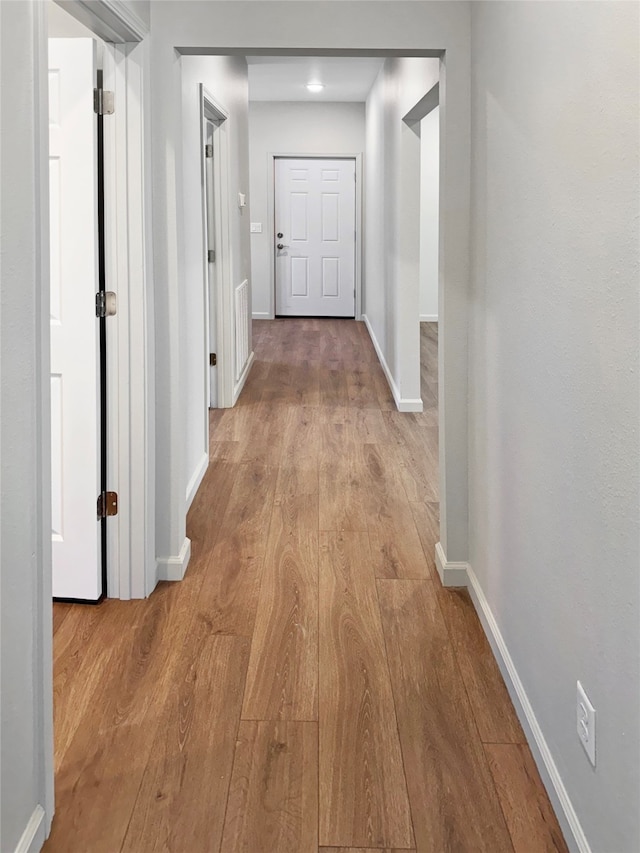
[46,2,152,601]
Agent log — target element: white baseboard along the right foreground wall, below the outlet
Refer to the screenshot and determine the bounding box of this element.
[462,564,591,853]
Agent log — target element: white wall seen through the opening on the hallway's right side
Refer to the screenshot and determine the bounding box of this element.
[420,107,440,322]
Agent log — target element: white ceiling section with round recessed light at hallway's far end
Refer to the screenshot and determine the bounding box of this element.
[247,56,384,101]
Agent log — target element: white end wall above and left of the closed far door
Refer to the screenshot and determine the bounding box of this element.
[249,101,365,319]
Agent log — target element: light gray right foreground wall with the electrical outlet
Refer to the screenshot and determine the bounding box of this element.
[469,2,640,853]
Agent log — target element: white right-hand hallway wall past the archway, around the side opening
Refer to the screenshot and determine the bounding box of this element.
[364,58,439,411]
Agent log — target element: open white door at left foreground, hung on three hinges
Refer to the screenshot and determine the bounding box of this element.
[49,38,102,601]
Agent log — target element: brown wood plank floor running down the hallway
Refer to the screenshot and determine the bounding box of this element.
[45,320,566,853]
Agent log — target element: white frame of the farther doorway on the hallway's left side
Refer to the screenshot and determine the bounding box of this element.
[200,83,234,412]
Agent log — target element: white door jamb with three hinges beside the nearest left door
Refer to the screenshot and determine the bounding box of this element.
[104,43,156,599]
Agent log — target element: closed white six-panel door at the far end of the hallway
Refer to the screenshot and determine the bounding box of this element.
[274,157,356,317]
